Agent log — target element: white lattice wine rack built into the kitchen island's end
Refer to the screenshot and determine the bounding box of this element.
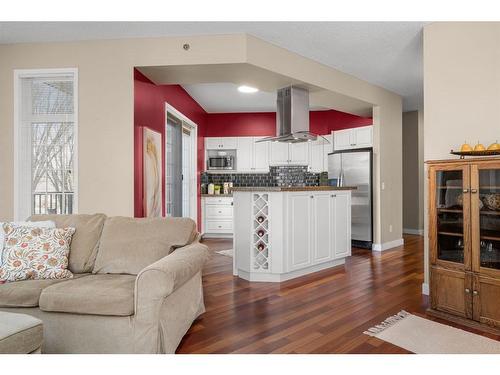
[252,193,270,271]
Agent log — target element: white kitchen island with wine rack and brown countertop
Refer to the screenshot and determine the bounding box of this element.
[233,186,355,282]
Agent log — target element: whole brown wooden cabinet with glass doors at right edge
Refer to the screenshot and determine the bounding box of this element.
[428,158,500,329]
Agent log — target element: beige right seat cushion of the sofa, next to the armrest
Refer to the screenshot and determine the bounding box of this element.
[40,275,135,316]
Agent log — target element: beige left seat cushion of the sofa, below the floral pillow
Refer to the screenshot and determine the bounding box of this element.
[0,274,88,307]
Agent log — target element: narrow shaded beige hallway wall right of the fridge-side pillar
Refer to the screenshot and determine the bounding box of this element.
[403,111,424,233]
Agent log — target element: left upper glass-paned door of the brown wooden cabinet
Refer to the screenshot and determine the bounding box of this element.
[429,165,471,271]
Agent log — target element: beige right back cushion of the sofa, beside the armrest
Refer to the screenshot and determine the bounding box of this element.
[92,217,197,275]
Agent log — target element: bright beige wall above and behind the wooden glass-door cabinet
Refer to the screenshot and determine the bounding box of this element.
[424,22,500,288]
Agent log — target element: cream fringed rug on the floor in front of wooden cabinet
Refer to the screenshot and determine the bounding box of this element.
[364,310,500,354]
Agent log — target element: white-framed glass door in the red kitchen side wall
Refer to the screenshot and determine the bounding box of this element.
[165,104,198,221]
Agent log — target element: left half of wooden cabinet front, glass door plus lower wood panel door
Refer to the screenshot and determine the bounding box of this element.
[429,165,472,318]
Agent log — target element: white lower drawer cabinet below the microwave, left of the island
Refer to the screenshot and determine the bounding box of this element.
[201,196,233,237]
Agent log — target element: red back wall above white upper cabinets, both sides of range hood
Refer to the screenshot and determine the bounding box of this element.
[205,109,372,137]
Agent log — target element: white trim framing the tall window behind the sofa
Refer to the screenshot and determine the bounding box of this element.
[14,68,79,221]
